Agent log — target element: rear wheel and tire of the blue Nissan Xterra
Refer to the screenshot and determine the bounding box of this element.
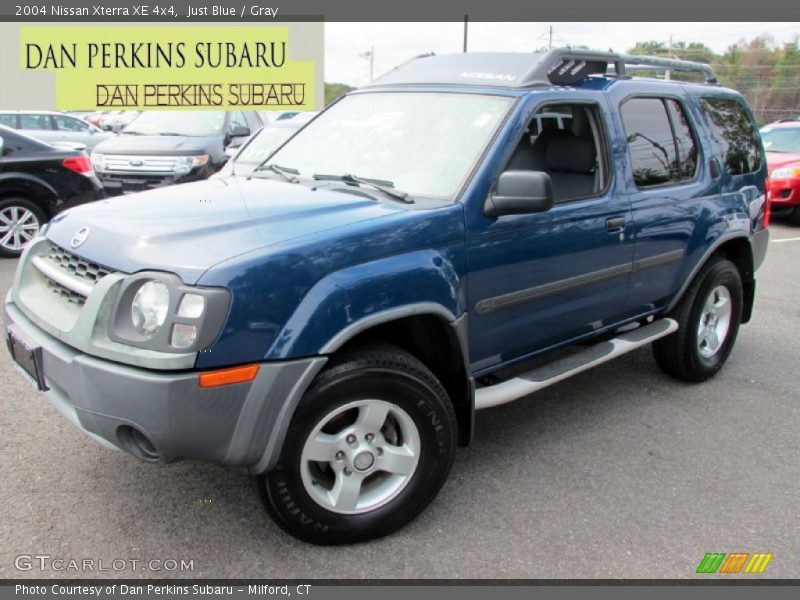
[653,258,743,383]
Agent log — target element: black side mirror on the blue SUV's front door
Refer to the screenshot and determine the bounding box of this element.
[483,171,553,218]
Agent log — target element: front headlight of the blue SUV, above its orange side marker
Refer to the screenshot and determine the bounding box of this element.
[108,271,231,353]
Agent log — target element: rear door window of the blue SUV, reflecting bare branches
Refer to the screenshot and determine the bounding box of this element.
[620,98,697,187]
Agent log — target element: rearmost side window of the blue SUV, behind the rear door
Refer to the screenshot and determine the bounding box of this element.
[700,98,761,175]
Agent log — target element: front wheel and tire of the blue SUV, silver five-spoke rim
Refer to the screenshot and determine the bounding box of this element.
[256,344,456,544]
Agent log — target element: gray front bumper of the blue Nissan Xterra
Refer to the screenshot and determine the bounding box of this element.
[3,301,326,472]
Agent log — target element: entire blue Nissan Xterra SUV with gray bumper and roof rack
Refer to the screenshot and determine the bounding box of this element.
[4,49,769,544]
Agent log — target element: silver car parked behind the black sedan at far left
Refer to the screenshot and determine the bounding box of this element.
[0,110,113,151]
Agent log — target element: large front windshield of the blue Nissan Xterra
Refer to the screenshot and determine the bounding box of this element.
[270,92,514,199]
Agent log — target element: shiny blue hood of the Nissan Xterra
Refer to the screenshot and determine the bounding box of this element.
[45,177,403,284]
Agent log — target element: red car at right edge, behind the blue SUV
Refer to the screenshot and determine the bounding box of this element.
[761,120,800,225]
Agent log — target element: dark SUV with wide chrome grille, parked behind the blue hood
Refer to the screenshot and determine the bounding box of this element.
[92,111,263,194]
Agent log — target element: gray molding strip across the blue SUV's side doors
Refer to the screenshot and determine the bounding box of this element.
[475,250,683,315]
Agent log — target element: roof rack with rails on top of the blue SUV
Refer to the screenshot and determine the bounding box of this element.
[523,48,717,85]
